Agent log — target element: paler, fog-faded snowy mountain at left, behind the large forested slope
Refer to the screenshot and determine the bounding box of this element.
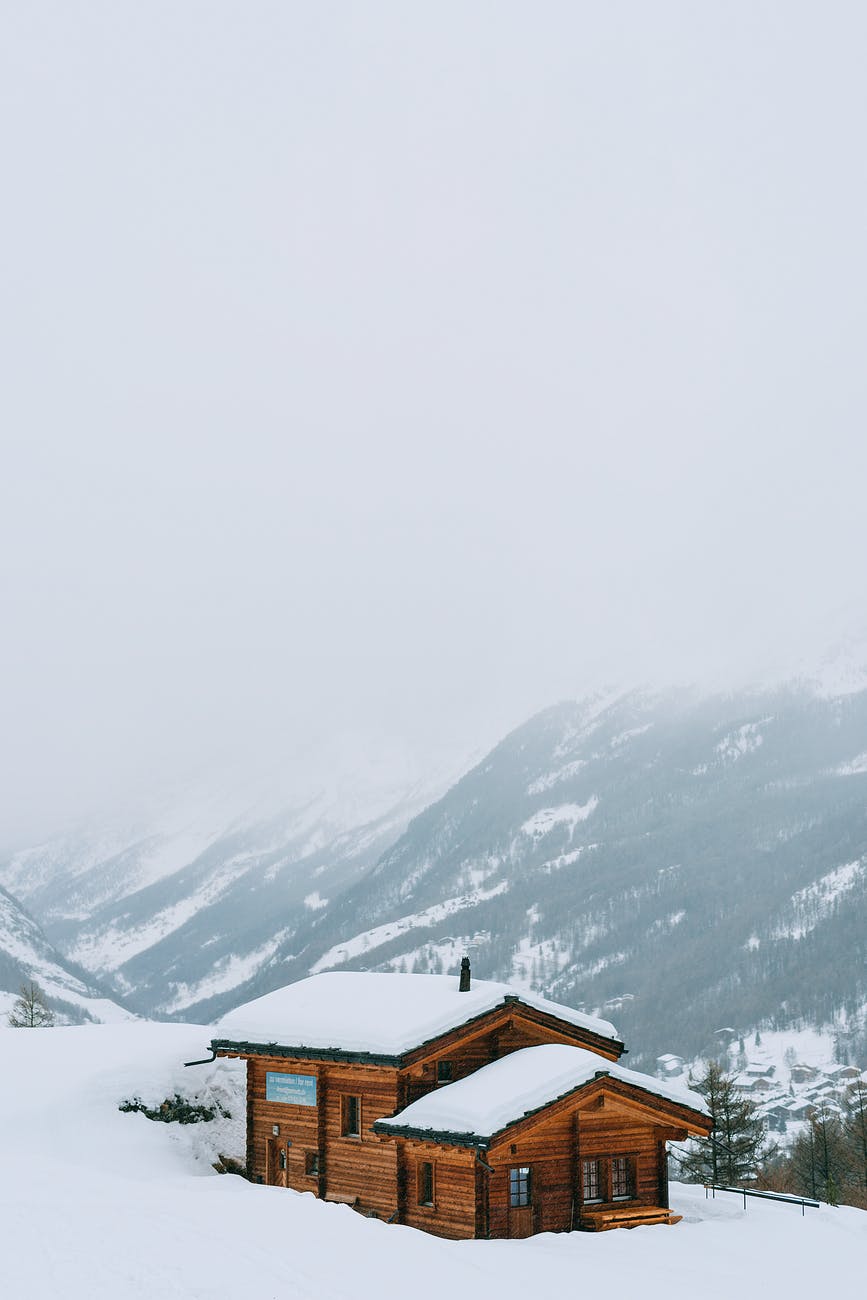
[0,745,463,1018]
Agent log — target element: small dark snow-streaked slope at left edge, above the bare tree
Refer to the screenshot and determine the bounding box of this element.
[0,889,134,1023]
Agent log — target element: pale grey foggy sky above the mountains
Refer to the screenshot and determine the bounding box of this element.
[0,0,867,840]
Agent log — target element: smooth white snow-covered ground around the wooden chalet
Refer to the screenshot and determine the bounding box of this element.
[0,1022,867,1300]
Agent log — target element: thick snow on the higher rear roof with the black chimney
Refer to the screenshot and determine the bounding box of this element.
[216,971,619,1063]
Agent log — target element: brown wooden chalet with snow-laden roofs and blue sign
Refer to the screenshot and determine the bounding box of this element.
[211,961,711,1238]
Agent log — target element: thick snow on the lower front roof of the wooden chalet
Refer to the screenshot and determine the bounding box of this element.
[377,1043,710,1139]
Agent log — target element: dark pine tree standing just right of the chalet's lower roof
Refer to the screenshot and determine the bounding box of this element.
[681,1061,773,1187]
